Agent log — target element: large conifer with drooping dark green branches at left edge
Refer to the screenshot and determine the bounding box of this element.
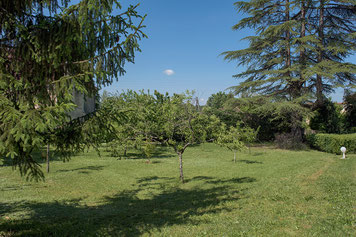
[0,0,145,178]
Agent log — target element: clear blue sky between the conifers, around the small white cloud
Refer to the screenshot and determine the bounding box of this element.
[100,0,354,104]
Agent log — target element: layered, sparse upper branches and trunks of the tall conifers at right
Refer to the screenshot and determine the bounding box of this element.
[223,0,356,102]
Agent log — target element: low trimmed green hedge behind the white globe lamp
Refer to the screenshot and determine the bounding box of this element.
[306,133,356,154]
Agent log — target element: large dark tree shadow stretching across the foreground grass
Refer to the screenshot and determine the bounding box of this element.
[0,176,253,236]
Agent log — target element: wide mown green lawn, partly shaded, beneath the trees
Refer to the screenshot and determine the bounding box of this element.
[0,144,356,236]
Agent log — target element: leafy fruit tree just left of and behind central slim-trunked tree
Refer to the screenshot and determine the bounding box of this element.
[103,90,168,159]
